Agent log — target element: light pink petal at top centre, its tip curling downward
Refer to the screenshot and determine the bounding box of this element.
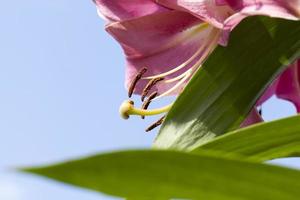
[157,0,234,28]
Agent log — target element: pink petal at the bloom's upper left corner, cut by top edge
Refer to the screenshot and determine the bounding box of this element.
[93,0,169,22]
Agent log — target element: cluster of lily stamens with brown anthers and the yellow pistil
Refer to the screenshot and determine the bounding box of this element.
[119,29,220,128]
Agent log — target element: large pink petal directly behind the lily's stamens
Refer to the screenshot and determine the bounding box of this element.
[106,11,212,93]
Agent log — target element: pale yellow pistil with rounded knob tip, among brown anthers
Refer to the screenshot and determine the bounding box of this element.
[119,100,173,119]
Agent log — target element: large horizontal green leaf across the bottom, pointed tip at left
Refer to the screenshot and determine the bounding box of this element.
[25,151,300,200]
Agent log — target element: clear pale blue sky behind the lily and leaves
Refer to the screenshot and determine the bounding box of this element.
[0,0,300,200]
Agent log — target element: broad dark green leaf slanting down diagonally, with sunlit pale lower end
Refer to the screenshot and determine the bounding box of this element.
[154,17,300,150]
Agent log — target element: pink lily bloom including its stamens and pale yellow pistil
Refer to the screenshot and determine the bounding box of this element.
[94,0,300,129]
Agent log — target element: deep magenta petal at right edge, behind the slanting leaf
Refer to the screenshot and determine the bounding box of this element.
[276,60,300,113]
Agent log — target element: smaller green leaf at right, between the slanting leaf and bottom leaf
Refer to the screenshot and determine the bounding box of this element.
[193,116,300,162]
